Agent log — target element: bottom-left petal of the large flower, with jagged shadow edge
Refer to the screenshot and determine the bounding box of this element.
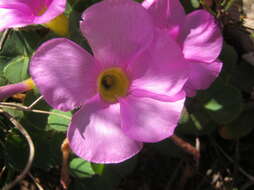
[67,96,142,163]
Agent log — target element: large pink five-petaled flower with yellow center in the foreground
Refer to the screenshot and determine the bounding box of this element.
[30,0,188,163]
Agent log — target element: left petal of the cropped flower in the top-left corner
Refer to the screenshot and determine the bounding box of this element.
[0,1,34,31]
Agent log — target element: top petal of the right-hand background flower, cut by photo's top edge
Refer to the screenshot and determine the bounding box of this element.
[142,0,185,37]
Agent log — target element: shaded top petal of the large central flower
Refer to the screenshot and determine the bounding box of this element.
[80,0,153,67]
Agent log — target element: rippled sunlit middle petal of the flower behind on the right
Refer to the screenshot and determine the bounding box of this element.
[180,10,223,62]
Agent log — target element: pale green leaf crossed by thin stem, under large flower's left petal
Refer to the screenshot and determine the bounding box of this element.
[48,110,72,131]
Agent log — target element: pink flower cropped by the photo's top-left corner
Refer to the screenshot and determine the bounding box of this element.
[0,0,66,31]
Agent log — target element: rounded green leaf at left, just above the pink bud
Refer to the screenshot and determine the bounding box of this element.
[3,56,29,83]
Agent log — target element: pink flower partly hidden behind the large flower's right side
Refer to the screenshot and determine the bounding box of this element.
[143,0,223,96]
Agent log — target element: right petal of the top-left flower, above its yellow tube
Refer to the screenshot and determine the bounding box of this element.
[34,0,66,24]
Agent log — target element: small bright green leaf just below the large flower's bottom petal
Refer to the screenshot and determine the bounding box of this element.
[69,158,96,178]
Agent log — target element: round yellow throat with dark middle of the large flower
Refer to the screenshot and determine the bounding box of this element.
[97,67,129,102]
